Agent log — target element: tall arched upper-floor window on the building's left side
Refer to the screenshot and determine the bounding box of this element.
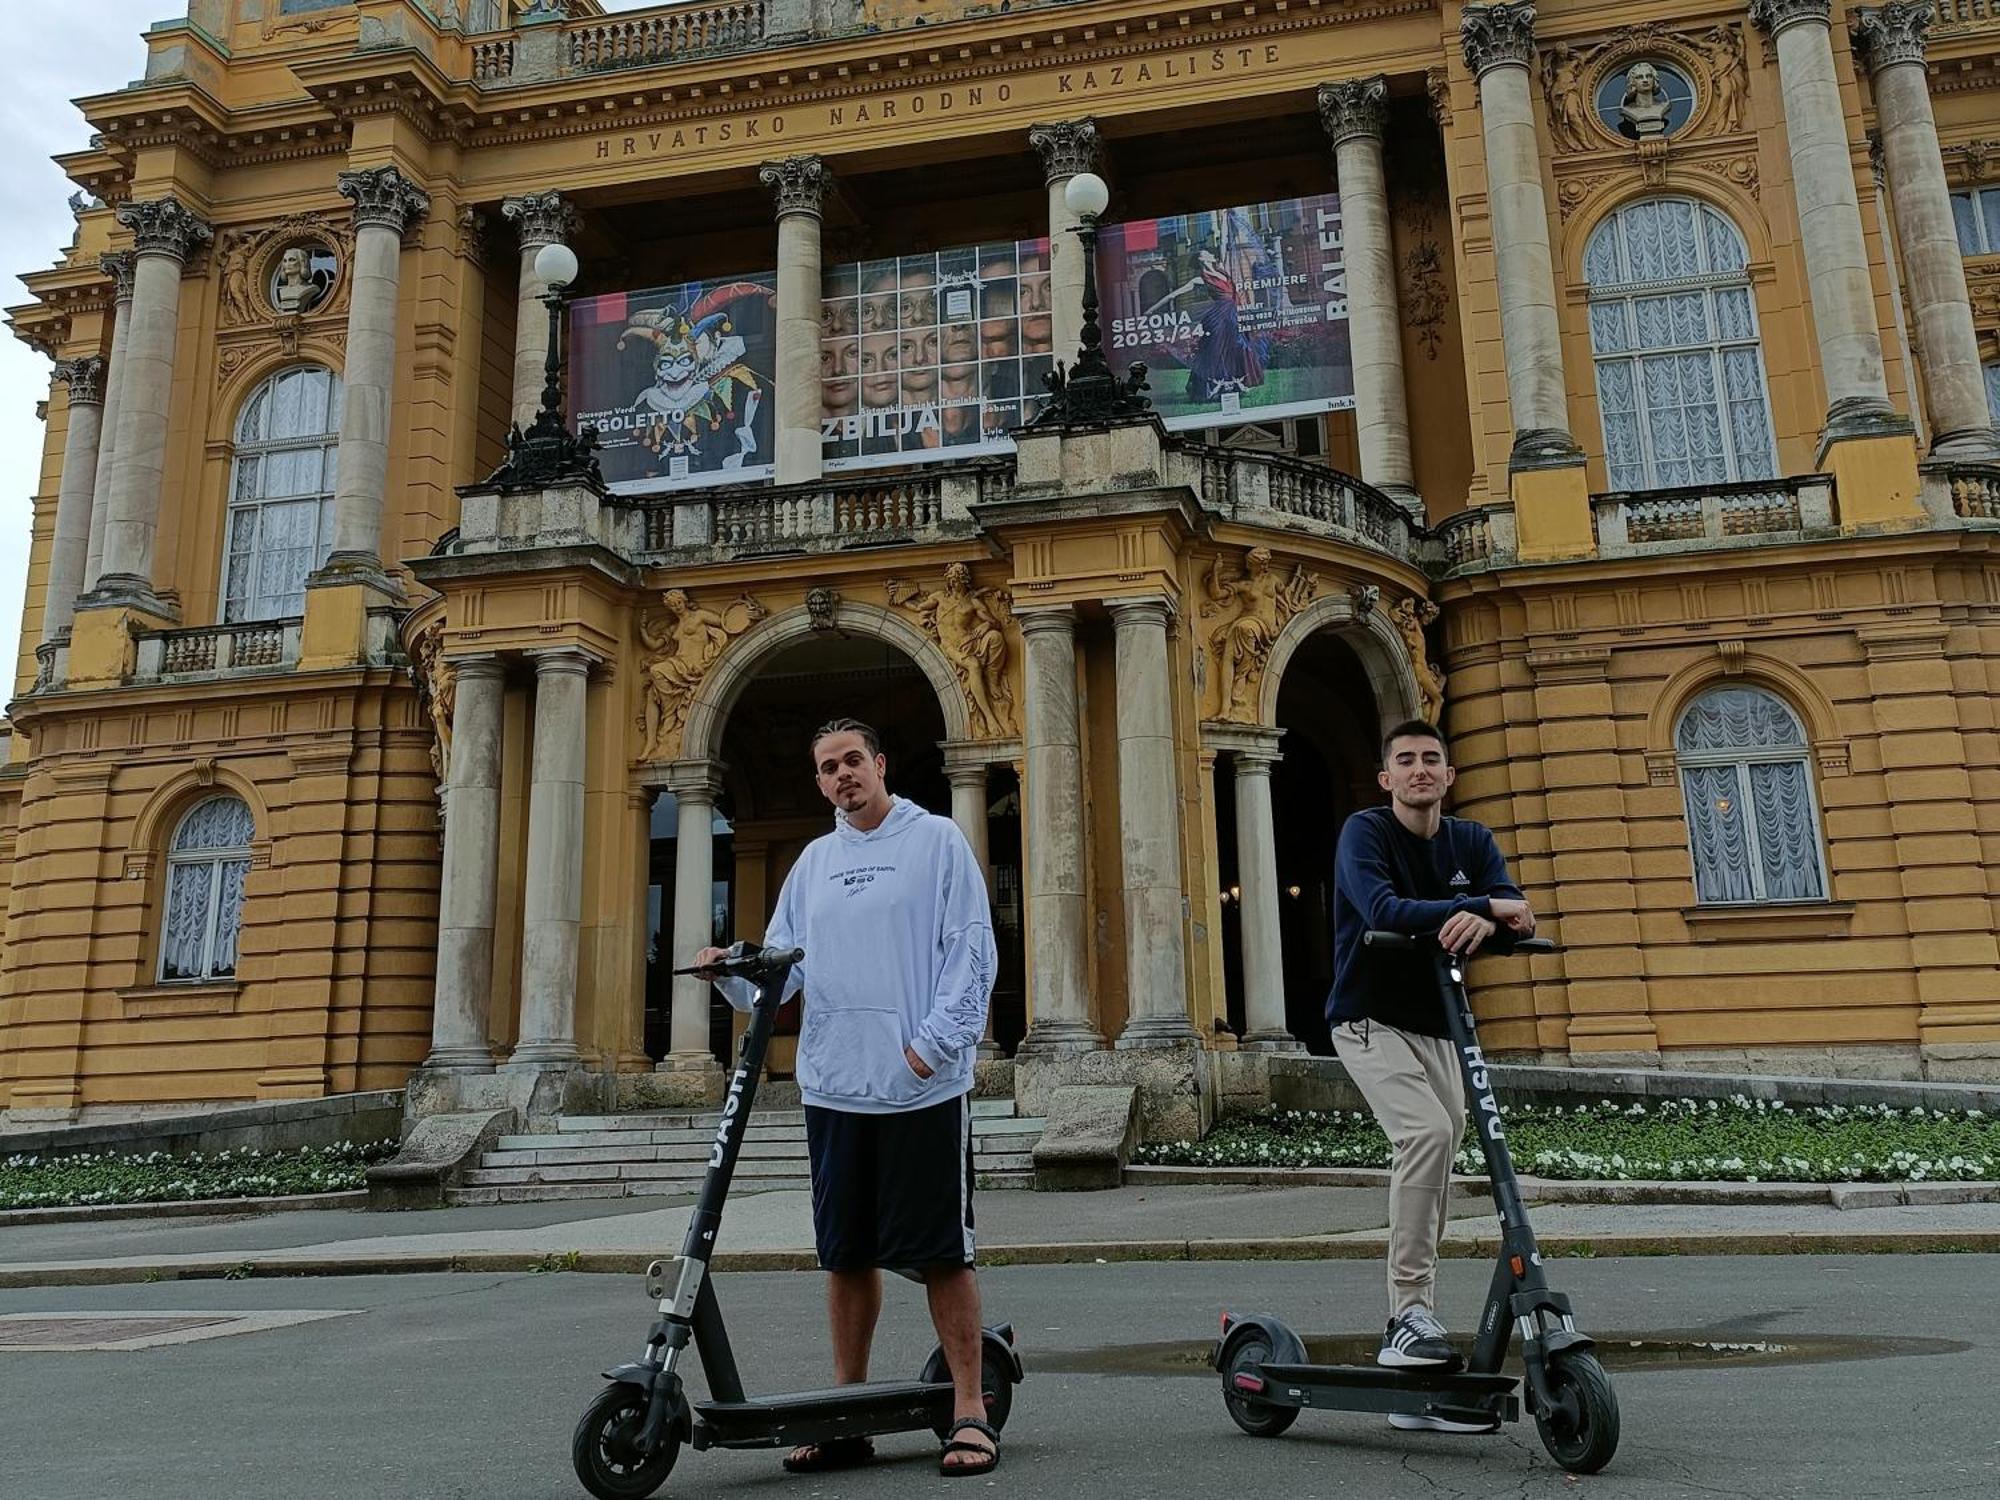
[222,364,340,620]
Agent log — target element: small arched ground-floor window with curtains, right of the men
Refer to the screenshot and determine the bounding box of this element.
[1674,686,1826,906]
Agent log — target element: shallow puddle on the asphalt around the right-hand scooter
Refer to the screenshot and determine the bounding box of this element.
[1026,1330,1972,1378]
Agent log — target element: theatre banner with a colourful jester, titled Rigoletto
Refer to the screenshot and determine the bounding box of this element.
[570,272,778,494]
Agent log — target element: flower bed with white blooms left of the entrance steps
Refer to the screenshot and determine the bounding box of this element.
[0,1140,396,1208]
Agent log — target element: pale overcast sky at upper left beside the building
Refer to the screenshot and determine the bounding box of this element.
[0,0,648,704]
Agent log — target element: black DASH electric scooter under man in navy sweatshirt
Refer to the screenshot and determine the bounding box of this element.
[1214,932,1618,1474]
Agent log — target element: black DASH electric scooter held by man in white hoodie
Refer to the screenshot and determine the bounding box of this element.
[570,942,1022,1500]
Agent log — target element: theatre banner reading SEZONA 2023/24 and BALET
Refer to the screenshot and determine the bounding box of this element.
[1098,194,1354,428]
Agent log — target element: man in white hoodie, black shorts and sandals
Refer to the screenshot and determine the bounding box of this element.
[696,718,1000,1474]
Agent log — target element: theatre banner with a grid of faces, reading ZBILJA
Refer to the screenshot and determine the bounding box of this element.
[820,240,1054,470]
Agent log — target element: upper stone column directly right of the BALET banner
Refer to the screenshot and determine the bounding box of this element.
[1320,74,1424,524]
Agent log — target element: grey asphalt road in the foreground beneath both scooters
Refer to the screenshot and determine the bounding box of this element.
[0,1256,2000,1500]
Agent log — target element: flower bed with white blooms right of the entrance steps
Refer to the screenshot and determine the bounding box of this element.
[1134,1096,2000,1182]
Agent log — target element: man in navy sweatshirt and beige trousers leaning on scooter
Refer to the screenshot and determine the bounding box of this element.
[1326,720,1534,1432]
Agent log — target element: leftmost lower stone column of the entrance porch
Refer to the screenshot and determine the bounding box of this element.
[424,656,506,1072]
